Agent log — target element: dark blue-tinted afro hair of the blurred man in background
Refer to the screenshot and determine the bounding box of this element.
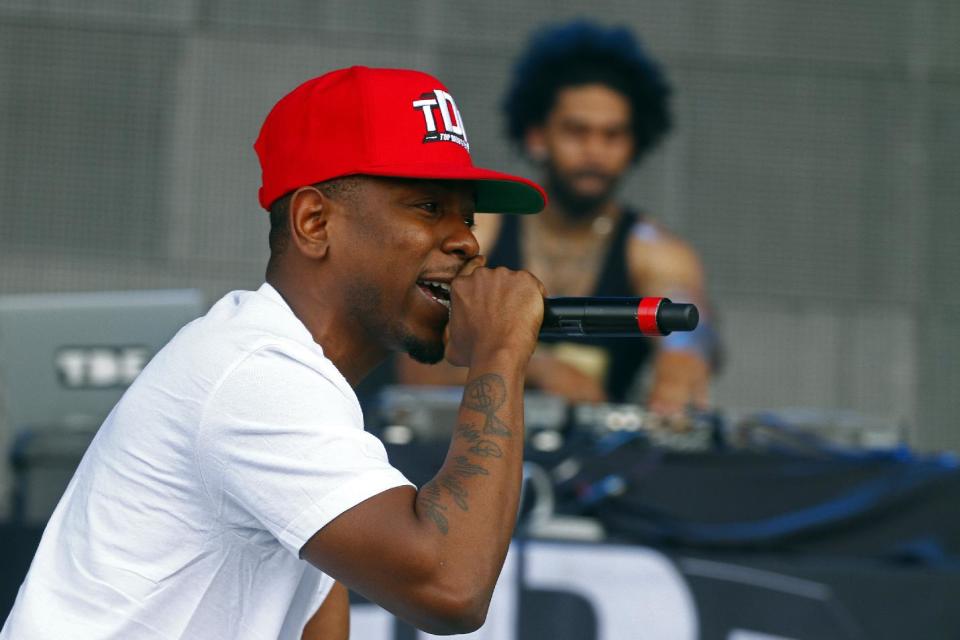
[503,20,672,160]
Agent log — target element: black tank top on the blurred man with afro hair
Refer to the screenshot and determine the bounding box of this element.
[487,209,652,402]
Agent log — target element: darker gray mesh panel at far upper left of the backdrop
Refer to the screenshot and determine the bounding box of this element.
[0,26,178,259]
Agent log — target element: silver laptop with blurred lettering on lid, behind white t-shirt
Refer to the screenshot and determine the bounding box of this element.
[0,290,206,521]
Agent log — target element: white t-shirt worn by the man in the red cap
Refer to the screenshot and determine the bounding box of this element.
[0,284,409,640]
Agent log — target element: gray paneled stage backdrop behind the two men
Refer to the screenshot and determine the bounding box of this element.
[0,0,960,449]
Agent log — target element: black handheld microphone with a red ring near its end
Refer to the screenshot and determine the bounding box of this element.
[540,297,700,338]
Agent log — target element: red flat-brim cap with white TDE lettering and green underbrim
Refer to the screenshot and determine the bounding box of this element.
[253,67,547,213]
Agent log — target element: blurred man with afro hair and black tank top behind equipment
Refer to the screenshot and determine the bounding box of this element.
[399,20,716,415]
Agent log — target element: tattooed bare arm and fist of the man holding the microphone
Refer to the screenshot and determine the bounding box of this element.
[302,269,543,633]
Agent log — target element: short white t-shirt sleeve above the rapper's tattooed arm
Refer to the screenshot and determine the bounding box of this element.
[196,346,410,555]
